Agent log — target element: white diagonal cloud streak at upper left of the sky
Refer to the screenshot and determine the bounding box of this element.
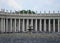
[7,0,23,10]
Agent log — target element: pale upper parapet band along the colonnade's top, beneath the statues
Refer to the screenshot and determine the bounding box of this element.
[0,13,60,16]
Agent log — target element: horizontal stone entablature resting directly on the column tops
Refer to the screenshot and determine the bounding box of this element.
[0,14,60,19]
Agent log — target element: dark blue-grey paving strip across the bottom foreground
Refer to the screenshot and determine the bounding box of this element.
[0,37,60,43]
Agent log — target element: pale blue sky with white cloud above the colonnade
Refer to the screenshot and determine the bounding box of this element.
[0,0,60,12]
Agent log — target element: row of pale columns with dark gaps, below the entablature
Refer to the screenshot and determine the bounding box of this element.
[0,18,60,32]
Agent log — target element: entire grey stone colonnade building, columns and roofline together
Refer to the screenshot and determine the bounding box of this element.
[0,13,60,32]
